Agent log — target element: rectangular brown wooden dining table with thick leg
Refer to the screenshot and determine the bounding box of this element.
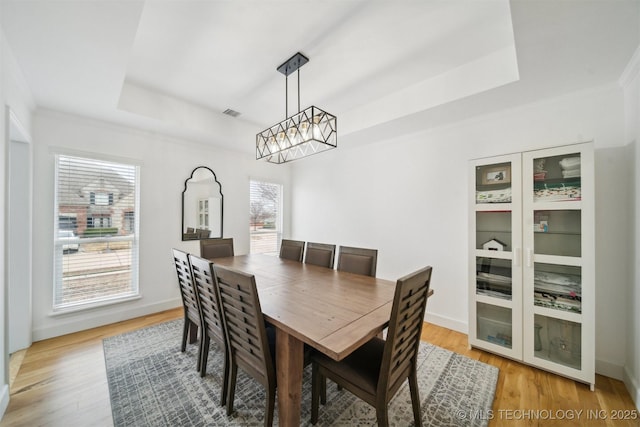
[211,254,410,426]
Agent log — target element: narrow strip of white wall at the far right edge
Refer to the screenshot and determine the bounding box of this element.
[620,47,640,409]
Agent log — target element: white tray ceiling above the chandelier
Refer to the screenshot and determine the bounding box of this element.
[2,0,640,152]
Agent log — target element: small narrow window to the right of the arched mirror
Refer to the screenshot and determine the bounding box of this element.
[249,181,282,255]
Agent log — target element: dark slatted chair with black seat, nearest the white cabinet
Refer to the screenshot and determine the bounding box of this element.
[311,266,432,426]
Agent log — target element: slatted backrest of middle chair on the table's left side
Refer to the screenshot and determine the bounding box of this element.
[189,255,225,348]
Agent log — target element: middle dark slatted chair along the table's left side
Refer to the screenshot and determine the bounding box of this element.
[189,255,229,406]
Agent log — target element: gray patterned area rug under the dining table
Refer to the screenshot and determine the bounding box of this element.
[103,320,498,427]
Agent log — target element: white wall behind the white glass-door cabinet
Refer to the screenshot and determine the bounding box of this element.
[292,84,630,378]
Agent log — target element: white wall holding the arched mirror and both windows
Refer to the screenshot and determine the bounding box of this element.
[33,111,289,341]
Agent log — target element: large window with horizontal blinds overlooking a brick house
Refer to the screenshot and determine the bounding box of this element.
[53,155,139,310]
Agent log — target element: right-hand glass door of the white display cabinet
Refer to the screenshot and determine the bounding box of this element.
[523,144,595,384]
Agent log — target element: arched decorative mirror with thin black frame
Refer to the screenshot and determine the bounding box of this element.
[182,166,224,240]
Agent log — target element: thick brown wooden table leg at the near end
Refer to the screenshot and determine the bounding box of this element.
[276,327,304,426]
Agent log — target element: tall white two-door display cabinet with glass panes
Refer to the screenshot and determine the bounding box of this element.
[469,143,595,388]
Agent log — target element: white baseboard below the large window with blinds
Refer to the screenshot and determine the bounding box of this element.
[33,298,182,342]
